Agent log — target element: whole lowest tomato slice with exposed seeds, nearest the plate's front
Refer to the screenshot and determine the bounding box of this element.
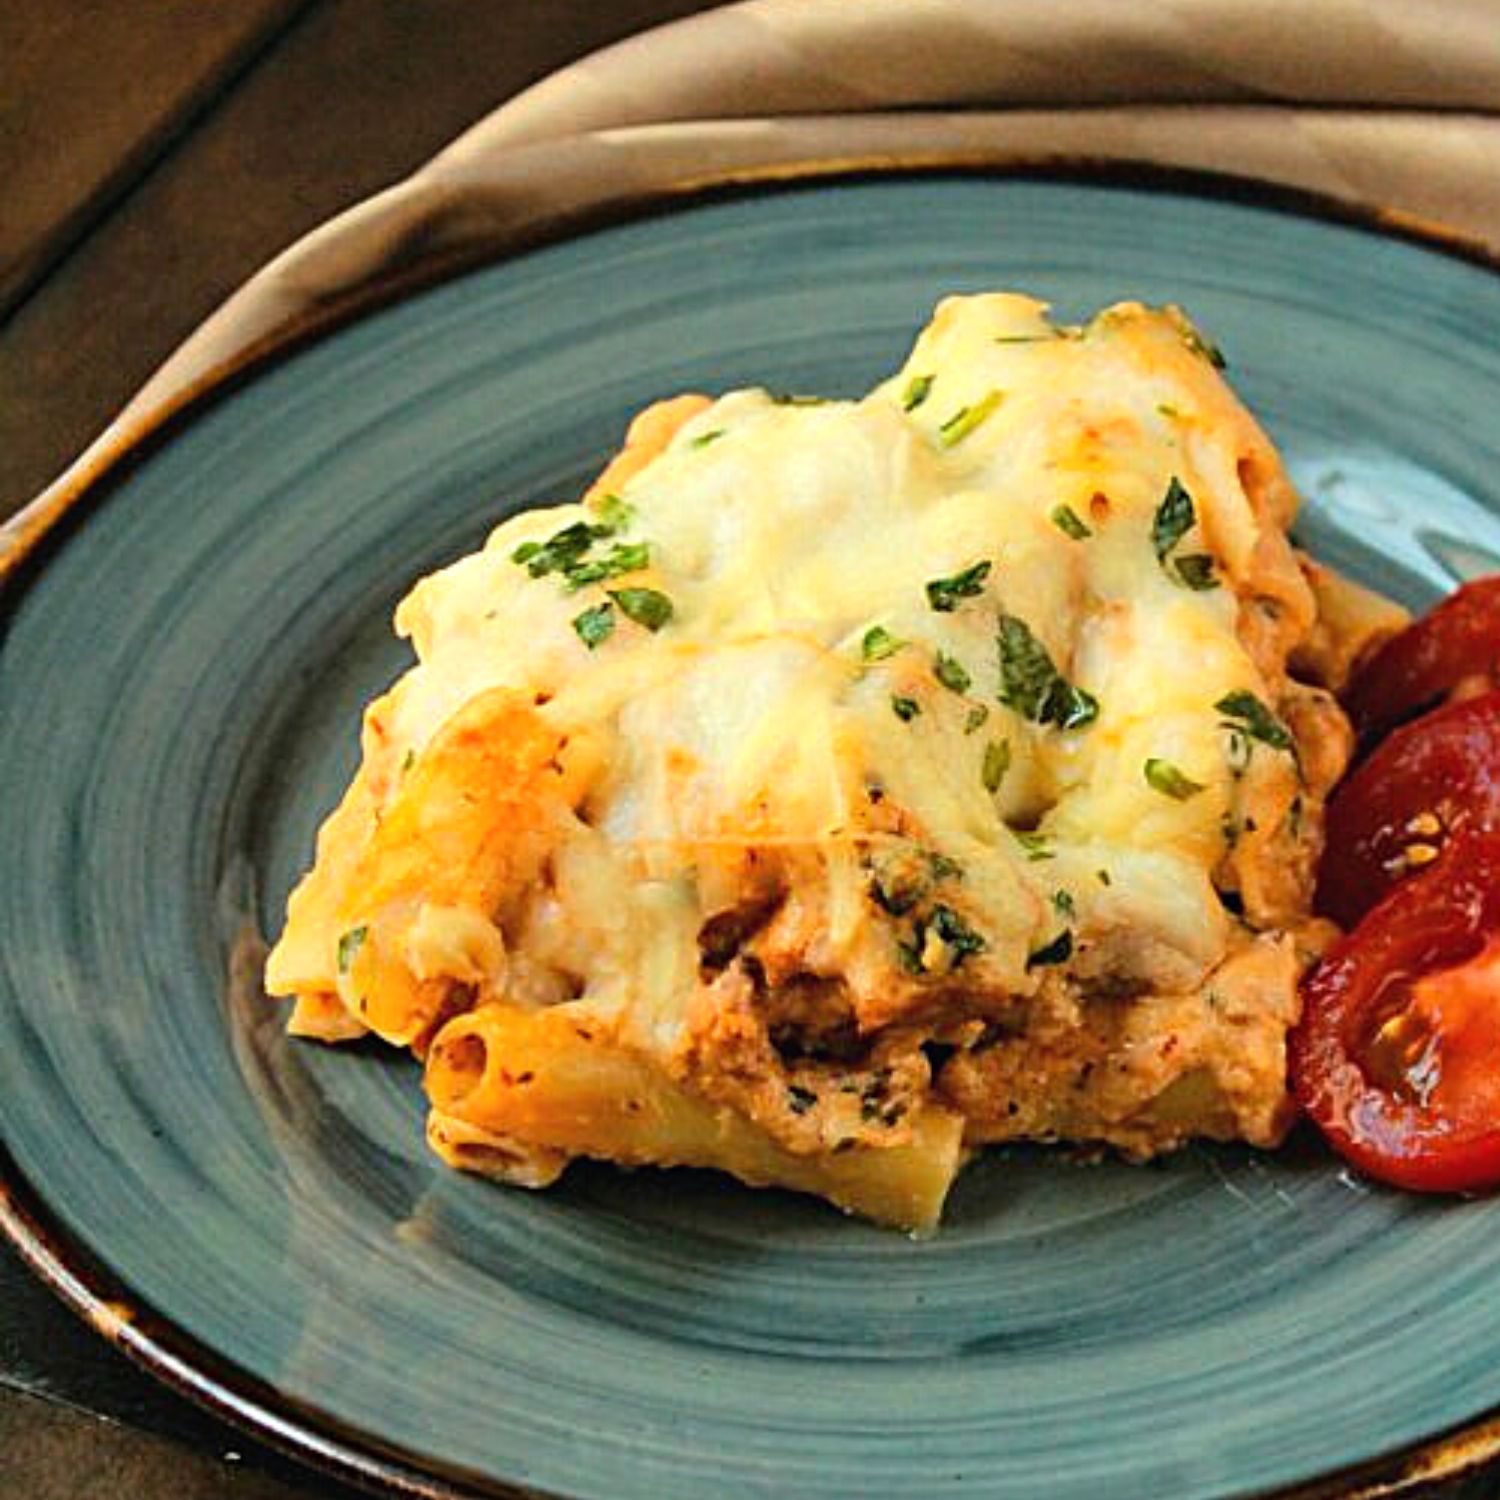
[1287,833,1500,1193]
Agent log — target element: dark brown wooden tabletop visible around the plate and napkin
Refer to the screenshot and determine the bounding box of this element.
[0,0,1500,1500]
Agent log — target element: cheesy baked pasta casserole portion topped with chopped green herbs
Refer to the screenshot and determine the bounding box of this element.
[269,294,1394,1230]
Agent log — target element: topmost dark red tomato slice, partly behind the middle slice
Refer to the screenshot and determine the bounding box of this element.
[1344,575,1500,744]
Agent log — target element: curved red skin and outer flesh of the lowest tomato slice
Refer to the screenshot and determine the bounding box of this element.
[1287,833,1500,1193]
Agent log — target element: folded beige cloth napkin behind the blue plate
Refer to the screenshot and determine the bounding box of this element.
[11,0,1500,572]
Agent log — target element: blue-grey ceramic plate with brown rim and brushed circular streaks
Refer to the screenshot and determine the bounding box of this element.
[0,173,1500,1500]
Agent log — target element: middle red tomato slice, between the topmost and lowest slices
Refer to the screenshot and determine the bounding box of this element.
[1317,693,1500,927]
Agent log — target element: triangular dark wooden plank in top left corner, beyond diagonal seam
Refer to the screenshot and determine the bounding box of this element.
[0,0,309,315]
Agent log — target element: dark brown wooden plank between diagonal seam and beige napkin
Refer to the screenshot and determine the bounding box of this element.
[0,0,726,516]
